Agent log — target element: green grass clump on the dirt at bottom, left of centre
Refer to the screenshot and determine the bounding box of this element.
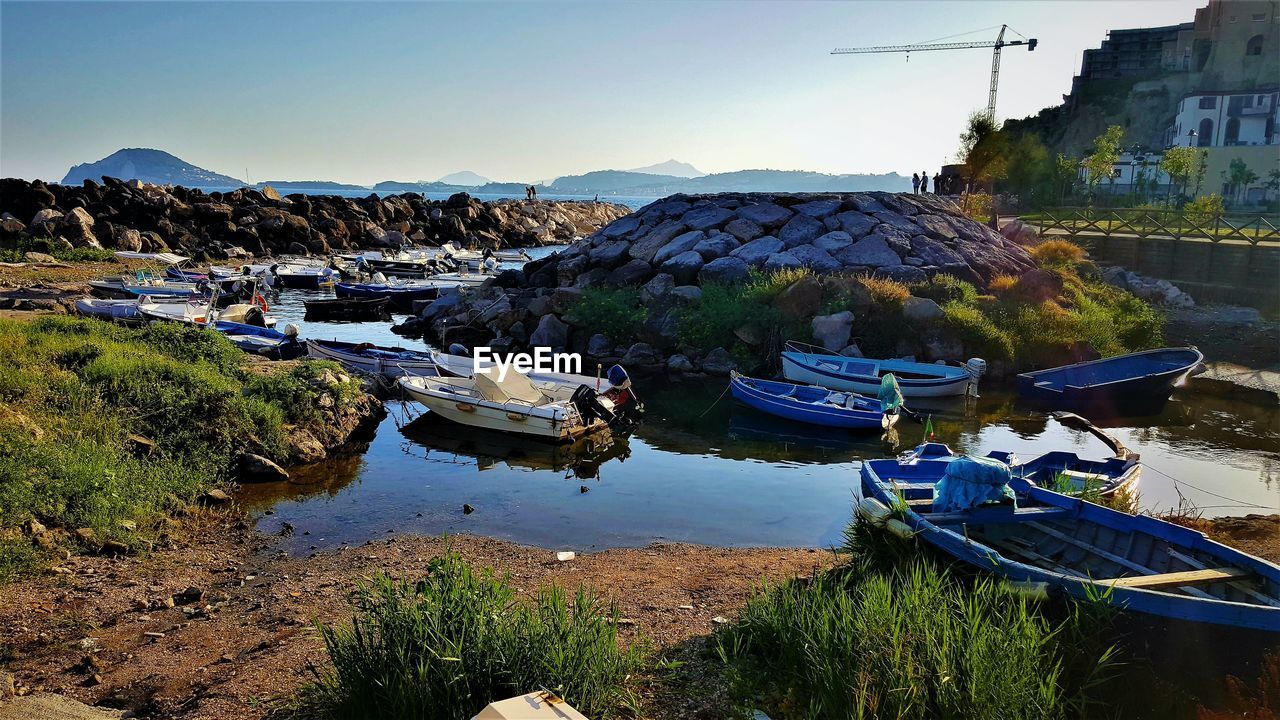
[284,548,641,720]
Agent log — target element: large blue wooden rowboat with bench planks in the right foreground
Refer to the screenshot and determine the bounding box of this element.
[859,446,1280,632]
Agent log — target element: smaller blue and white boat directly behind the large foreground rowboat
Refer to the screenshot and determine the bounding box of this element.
[902,442,1142,497]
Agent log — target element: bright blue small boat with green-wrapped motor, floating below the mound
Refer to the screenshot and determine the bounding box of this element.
[730,373,900,430]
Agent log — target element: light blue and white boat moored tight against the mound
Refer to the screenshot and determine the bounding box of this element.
[782,341,987,397]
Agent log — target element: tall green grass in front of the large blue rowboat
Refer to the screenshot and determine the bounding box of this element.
[716,515,1114,720]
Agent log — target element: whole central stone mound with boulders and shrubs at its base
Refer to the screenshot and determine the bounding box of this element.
[399,192,1039,374]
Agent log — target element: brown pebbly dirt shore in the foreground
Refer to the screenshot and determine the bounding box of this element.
[0,510,833,720]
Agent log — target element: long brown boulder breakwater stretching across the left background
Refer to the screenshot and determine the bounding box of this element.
[0,178,630,260]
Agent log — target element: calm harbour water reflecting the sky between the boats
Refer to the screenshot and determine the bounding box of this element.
[244,284,1280,552]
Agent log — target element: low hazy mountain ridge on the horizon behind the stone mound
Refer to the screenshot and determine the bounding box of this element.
[549,170,911,197]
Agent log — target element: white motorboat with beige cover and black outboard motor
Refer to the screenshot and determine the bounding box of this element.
[398,370,613,442]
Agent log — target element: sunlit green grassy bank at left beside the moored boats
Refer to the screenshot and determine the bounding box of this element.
[0,316,358,579]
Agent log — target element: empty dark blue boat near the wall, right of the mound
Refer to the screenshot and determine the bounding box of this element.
[1018,347,1204,416]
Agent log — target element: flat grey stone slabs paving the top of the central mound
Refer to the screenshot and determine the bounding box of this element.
[525,192,1036,288]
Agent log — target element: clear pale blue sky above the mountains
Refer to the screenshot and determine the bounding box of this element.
[0,0,1204,184]
